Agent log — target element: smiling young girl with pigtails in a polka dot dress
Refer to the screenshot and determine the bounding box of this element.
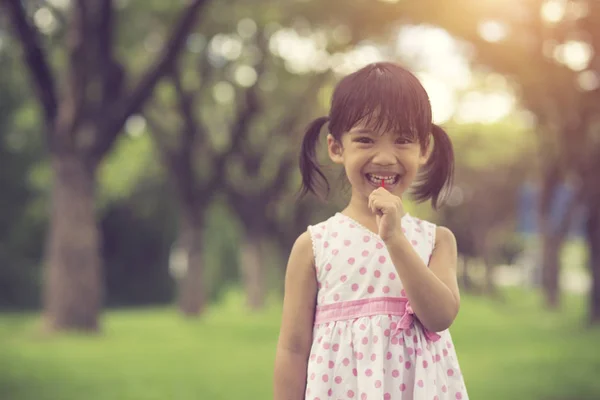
[274,63,468,400]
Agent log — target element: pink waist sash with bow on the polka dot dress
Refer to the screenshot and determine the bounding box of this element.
[315,297,440,342]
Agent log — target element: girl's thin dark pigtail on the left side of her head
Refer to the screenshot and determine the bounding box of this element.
[299,117,329,197]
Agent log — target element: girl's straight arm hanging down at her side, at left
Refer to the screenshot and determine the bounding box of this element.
[274,232,317,400]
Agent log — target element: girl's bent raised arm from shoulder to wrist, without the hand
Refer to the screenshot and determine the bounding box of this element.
[386,227,460,332]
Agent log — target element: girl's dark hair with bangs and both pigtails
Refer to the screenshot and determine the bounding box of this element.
[300,62,454,208]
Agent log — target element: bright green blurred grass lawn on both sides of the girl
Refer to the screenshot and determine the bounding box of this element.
[0,292,600,400]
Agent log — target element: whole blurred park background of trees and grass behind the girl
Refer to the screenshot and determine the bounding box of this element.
[0,0,600,400]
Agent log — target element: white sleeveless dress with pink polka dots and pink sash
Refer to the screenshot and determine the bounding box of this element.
[305,213,468,400]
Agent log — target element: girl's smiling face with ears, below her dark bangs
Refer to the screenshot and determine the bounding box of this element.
[327,119,427,197]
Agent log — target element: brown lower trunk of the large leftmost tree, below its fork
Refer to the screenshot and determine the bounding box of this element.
[44,154,102,331]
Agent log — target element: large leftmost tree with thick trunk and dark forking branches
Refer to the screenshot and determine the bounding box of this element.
[0,0,206,331]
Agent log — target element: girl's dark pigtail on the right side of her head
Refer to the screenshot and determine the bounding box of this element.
[414,124,454,208]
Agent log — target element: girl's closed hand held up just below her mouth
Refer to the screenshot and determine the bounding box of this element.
[369,187,405,242]
